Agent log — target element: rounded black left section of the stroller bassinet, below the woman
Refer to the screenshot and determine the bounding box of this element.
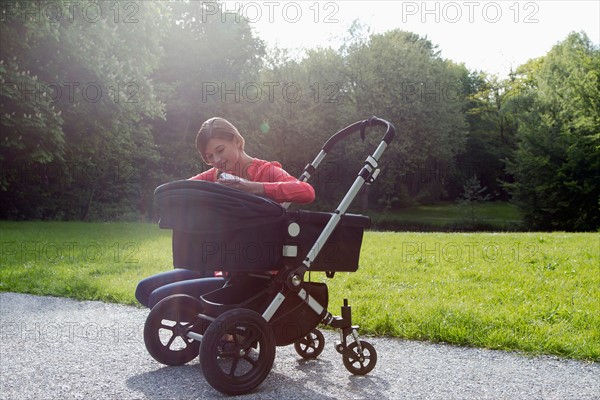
[154,180,286,271]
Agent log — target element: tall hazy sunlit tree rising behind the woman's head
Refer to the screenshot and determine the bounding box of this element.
[153,1,265,183]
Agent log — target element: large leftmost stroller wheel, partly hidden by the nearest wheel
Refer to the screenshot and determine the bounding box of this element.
[144,294,202,365]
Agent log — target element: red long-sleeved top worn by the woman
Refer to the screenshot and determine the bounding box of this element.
[190,158,315,204]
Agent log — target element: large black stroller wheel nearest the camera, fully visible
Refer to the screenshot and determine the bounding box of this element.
[200,309,275,395]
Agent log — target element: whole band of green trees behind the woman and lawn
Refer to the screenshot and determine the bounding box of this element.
[0,0,600,230]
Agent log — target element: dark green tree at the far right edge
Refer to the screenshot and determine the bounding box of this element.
[507,33,600,230]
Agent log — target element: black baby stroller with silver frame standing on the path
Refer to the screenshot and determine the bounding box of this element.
[144,117,395,395]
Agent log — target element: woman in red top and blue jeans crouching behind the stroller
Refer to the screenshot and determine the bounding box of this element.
[135,117,315,308]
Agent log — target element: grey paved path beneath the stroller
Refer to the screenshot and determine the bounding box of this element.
[0,293,600,400]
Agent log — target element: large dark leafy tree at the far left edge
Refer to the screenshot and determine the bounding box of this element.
[0,1,168,219]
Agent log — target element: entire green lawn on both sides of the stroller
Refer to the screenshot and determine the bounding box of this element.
[0,222,600,361]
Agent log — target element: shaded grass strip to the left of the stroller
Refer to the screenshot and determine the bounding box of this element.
[0,221,173,305]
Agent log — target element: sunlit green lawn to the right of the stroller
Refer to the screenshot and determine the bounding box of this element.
[330,232,600,361]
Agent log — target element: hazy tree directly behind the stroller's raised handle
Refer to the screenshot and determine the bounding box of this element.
[253,44,358,206]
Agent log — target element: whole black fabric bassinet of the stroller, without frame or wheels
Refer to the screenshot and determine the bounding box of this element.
[155,181,371,272]
